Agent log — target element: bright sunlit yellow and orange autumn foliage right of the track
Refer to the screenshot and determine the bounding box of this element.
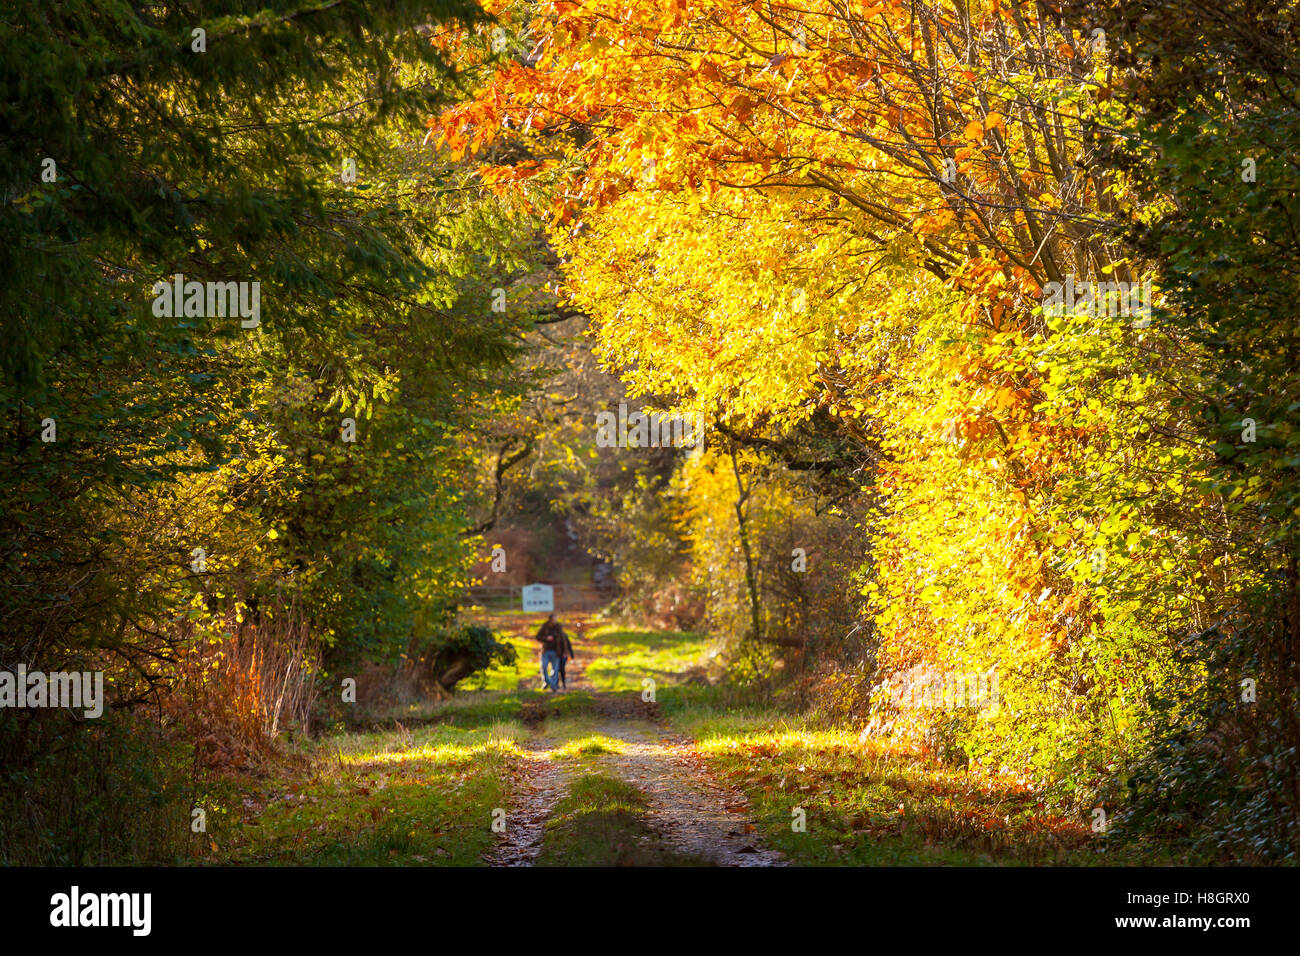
[430,0,1296,858]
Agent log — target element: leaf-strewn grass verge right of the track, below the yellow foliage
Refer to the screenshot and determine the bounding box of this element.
[675,711,1190,866]
